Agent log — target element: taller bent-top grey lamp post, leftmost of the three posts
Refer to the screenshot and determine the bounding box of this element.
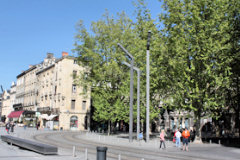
[118,43,134,142]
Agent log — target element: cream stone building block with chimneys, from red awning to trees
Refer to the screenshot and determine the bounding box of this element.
[13,52,90,130]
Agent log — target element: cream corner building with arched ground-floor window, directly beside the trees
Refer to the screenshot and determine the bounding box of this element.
[36,56,90,130]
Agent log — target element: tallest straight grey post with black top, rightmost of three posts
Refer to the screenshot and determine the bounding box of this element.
[146,31,151,142]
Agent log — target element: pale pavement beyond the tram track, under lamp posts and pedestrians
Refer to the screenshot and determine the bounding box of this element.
[78,133,240,160]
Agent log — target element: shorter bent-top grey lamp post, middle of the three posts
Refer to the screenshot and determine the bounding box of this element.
[123,62,141,140]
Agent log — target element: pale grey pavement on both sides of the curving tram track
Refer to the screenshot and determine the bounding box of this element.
[0,127,240,160]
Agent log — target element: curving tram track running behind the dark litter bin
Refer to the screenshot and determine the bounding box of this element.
[33,132,218,160]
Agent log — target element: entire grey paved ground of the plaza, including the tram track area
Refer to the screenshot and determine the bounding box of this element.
[0,127,240,160]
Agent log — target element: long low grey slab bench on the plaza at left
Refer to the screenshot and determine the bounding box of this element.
[1,135,58,155]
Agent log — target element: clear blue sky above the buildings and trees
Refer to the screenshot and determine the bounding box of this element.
[0,0,161,92]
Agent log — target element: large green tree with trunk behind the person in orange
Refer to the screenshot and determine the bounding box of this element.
[160,0,231,136]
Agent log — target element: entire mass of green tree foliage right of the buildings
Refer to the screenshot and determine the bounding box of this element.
[75,0,240,138]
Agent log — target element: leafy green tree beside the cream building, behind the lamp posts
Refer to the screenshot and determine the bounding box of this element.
[75,0,159,134]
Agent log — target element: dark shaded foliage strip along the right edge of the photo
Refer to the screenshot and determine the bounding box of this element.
[226,0,240,136]
